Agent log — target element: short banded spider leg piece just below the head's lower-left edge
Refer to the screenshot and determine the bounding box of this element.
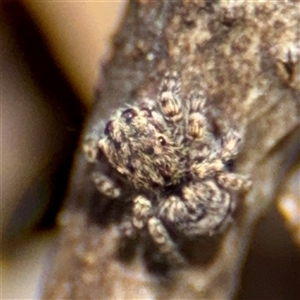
[91,172,121,199]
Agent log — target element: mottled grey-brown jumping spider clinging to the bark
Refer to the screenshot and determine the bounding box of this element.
[89,74,250,260]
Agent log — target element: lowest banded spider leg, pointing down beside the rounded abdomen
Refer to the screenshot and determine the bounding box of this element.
[148,217,184,264]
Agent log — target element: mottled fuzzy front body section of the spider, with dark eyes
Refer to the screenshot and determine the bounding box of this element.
[99,106,187,189]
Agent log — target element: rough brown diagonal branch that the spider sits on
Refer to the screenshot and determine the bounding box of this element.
[43,0,300,299]
